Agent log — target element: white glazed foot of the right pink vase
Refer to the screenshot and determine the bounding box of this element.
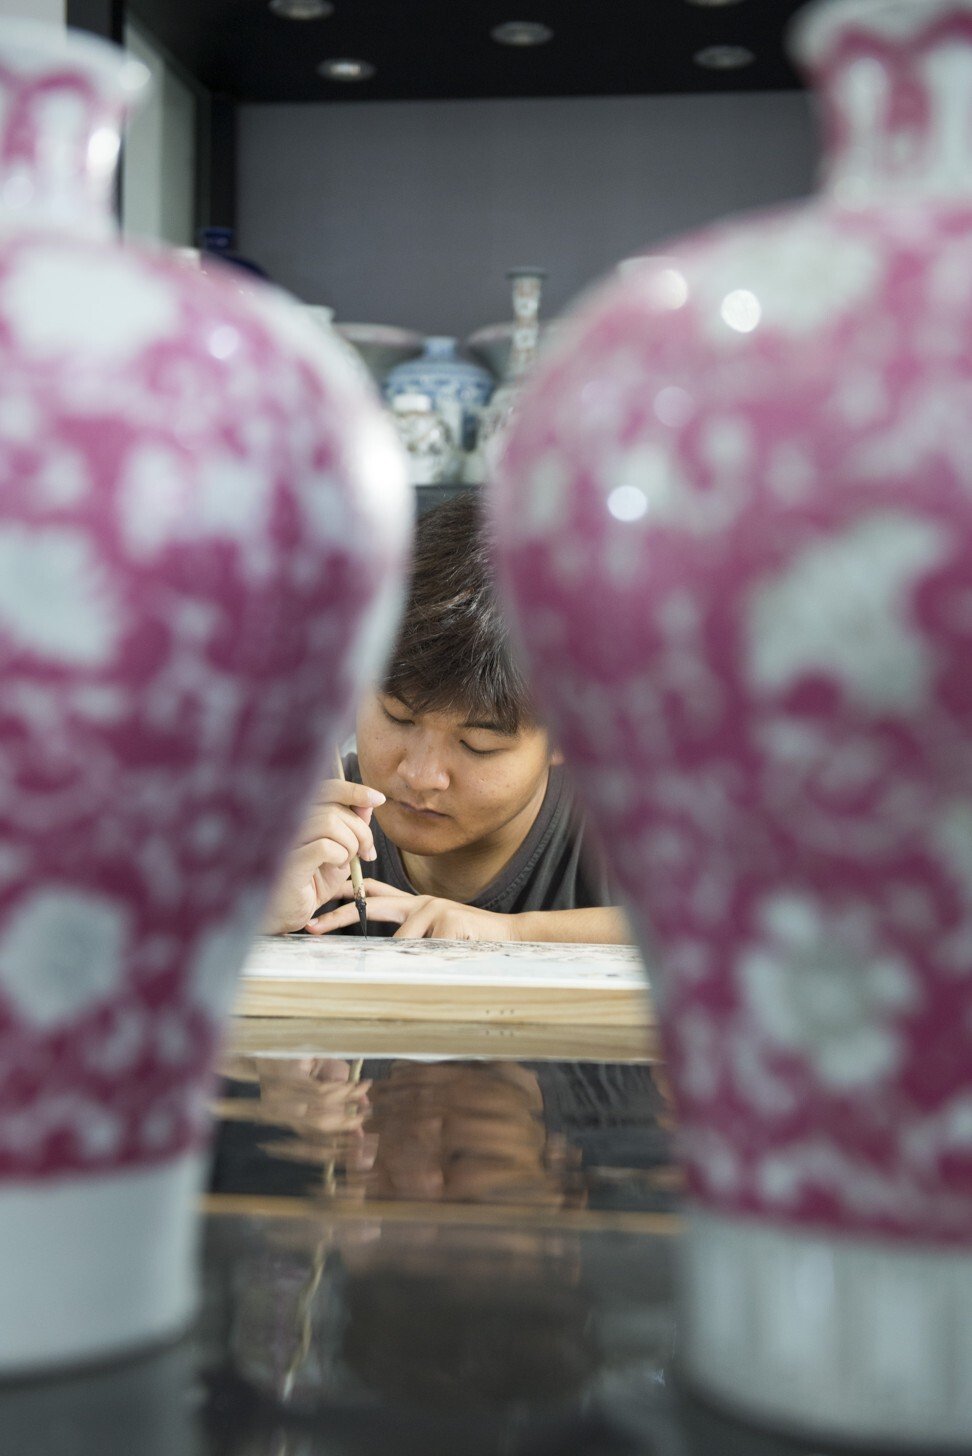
[681,1210,972,1450]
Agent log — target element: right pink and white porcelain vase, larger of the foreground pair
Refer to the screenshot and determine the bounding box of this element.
[493,0,972,1449]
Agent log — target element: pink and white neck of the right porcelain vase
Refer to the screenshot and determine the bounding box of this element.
[794,0,972,205]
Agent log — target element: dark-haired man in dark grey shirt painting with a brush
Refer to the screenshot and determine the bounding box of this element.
[265,494,629,942]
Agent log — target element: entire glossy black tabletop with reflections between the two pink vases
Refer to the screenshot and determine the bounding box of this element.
[0,1054,890,1456]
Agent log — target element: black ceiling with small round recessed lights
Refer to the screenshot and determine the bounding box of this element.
[127,0,802,102]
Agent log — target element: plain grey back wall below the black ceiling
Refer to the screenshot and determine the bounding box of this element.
[237,92,816,336]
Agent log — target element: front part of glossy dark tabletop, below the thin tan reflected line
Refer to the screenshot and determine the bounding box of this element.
[0,1200,896,1456]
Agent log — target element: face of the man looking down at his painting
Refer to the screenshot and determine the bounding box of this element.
[358,693,556,855]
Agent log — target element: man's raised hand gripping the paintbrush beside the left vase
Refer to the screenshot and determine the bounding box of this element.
[260,779,384,935]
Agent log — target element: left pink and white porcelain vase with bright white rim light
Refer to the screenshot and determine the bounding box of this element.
[0,23,410,1372]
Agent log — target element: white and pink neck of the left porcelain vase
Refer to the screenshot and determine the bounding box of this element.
[0,22,147,236]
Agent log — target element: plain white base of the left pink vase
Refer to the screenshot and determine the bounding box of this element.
[0,1152,208,1379]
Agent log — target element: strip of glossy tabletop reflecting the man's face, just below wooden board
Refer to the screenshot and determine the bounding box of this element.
[211,1057,678,1213]
